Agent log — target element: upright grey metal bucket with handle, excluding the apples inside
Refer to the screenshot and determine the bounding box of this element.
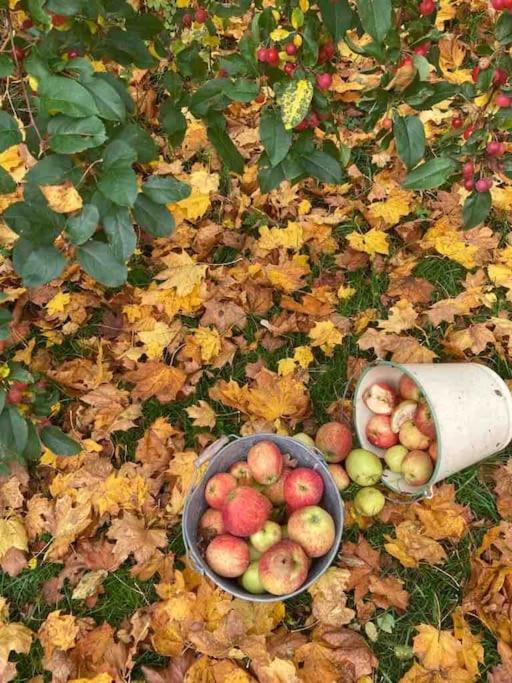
[183,434,343,602]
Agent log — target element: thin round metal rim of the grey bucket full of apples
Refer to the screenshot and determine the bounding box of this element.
[182,432,345,603]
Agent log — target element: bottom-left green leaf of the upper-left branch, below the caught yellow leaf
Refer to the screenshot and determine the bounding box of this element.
[12,239,66,287]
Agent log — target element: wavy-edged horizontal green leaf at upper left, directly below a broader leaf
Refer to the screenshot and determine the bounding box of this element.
[48,115,107,154]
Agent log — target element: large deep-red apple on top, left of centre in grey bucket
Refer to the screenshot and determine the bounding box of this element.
[222,486,272,536]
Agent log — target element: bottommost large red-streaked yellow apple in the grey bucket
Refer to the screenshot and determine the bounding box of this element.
[258,539,309,595]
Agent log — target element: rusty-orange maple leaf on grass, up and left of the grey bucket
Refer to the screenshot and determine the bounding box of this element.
[124,361,186,403]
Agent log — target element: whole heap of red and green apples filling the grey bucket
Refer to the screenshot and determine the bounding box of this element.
[198,440,336,595]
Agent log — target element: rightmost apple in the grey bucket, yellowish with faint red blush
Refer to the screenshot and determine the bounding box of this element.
[288,505,336,557]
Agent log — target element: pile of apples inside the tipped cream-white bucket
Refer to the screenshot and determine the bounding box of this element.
[363,375,437,486]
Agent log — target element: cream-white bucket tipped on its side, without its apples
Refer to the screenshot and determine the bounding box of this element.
[354,361,512,495]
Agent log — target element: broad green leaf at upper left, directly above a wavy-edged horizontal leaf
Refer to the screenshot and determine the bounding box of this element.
[38,76,98,118]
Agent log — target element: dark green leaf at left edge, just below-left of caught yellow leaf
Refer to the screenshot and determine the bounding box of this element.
[2,199,65,244]
